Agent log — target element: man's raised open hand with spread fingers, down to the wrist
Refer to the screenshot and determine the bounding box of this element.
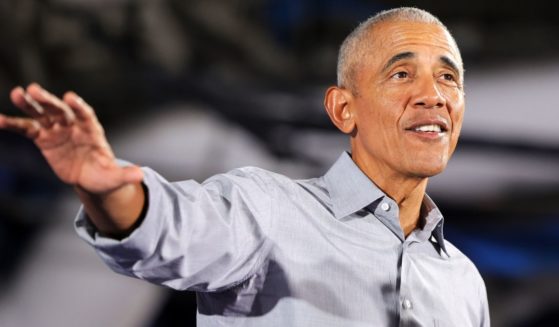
[0,88,141,194]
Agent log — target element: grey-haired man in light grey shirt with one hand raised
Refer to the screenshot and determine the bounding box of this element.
[0,8,489,326]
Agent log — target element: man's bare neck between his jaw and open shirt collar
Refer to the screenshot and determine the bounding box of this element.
[356,155,429,237]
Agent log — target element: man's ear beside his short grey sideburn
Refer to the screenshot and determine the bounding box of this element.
[324,86,355,134]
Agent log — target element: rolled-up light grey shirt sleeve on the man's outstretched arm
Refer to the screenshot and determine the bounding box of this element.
[75,167,274,291]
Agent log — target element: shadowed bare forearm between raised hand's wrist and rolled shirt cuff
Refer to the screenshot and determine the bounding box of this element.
[74,183,147,238]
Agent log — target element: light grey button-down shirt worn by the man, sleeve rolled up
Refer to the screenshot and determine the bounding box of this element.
[76,153,489,327]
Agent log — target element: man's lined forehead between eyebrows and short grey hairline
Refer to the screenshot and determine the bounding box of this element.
[368,21,462,68]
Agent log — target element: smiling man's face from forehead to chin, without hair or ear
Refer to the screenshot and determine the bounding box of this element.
[351,22,464,182]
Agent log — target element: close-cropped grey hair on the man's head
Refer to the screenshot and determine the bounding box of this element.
[337,7,461,91]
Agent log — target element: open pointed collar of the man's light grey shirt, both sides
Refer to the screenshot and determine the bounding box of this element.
[324,152,448,256]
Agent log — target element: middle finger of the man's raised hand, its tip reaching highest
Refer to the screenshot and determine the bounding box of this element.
[27,83,75,126]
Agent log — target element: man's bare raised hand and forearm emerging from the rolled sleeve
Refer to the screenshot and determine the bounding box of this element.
[0,84,146,237]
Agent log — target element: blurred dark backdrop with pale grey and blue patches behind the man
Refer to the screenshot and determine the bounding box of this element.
[0,0,559,327]
